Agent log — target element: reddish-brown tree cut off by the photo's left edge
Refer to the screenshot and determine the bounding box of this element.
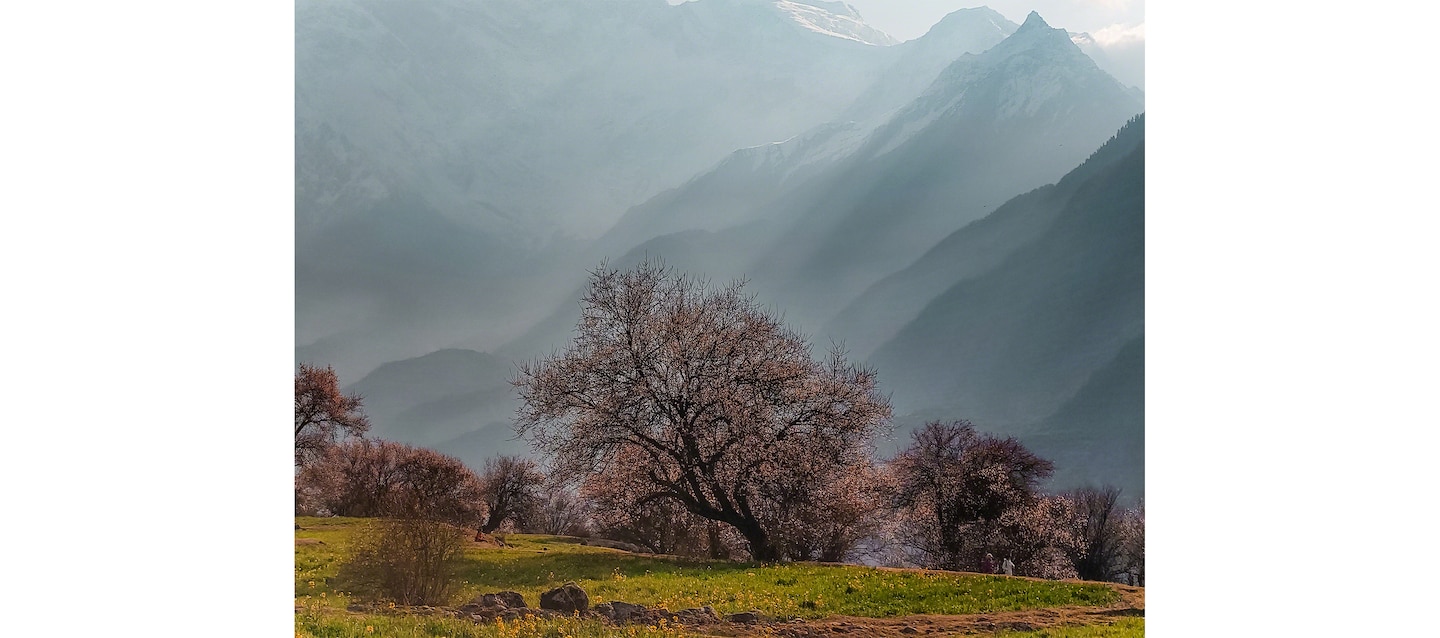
[295,363,370,465]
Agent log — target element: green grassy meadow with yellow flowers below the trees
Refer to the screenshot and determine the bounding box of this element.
[295,517,1143,638]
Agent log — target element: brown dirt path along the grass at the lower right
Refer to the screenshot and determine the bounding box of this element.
[687,585,1145,638]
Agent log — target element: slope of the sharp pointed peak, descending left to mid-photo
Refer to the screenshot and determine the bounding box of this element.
[750,13,1140,332]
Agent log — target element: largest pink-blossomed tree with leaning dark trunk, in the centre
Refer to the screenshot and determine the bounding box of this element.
[516,262,890,560]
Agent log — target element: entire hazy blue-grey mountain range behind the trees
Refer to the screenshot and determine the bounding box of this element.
[297,0,1145,495]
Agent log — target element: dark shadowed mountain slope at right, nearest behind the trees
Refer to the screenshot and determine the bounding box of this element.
[867,113,1145,494]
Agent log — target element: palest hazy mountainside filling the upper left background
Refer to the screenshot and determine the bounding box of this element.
[295,0,894,379]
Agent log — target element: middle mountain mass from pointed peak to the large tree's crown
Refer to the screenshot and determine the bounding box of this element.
[505,14,1139,364]
